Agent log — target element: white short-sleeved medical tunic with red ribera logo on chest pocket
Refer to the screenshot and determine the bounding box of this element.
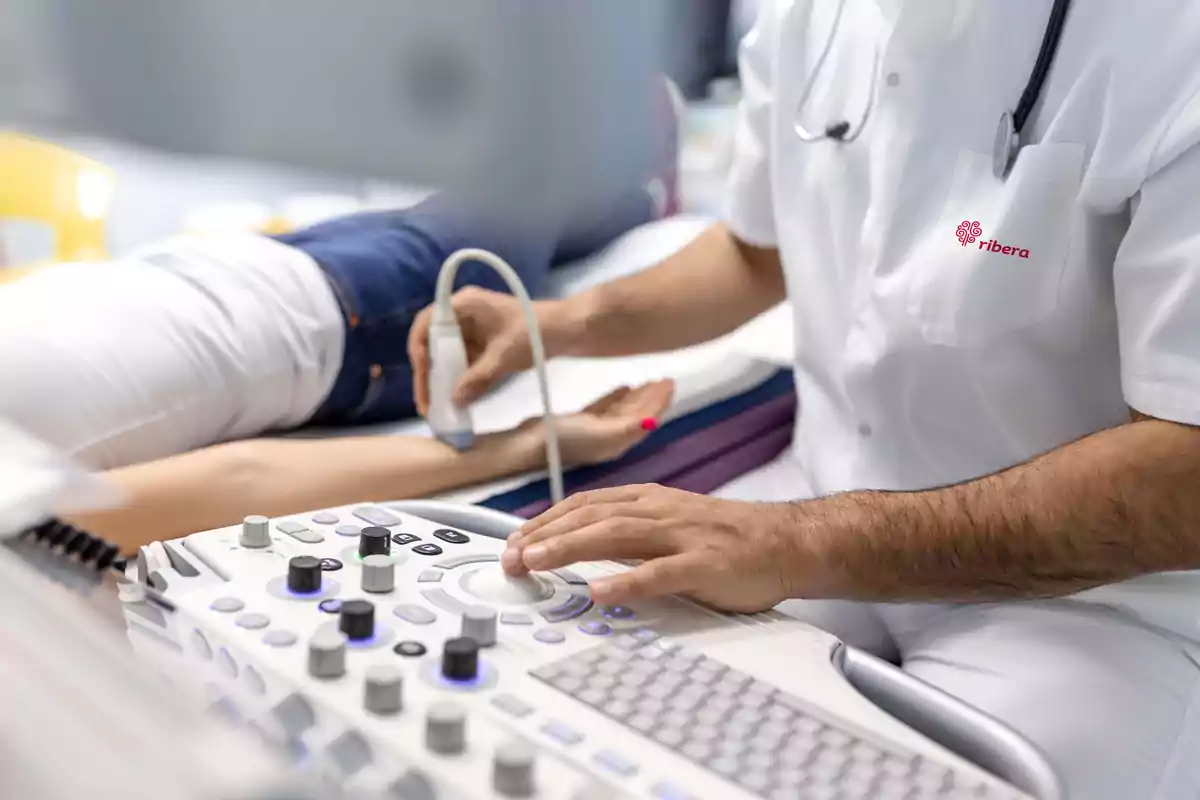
[727,0,1200,637]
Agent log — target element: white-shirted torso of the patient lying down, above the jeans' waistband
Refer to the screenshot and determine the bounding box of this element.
[0,236,342,468]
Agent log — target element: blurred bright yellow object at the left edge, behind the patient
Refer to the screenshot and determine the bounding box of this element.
[0,132,116,283]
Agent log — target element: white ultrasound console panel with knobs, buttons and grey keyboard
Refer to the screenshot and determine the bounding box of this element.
[126,504,1026,800]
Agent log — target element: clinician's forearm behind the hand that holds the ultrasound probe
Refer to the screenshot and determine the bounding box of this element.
[558,224,786,356]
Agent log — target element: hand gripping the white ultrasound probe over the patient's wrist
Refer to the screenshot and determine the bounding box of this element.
[408,287,578,416]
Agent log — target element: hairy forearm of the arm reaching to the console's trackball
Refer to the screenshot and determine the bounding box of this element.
[790,420,1200,601]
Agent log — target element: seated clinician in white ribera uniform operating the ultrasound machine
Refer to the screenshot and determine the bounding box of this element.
[410,0,1200,800]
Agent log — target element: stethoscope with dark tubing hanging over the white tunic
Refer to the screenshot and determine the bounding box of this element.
[793,0,1070,180]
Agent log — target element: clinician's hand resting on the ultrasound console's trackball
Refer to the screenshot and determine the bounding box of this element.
[500,486,816,613]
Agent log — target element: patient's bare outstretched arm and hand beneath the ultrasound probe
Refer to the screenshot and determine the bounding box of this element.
[66,381,672,552]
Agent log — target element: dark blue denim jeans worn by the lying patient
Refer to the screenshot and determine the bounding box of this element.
[278,190,654,426]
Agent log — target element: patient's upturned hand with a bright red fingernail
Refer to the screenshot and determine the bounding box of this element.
[521,380,674,467]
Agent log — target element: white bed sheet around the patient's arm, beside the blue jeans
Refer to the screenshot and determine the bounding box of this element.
[302,216,793,503]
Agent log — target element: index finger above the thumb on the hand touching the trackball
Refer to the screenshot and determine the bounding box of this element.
[521,517,674,570]
